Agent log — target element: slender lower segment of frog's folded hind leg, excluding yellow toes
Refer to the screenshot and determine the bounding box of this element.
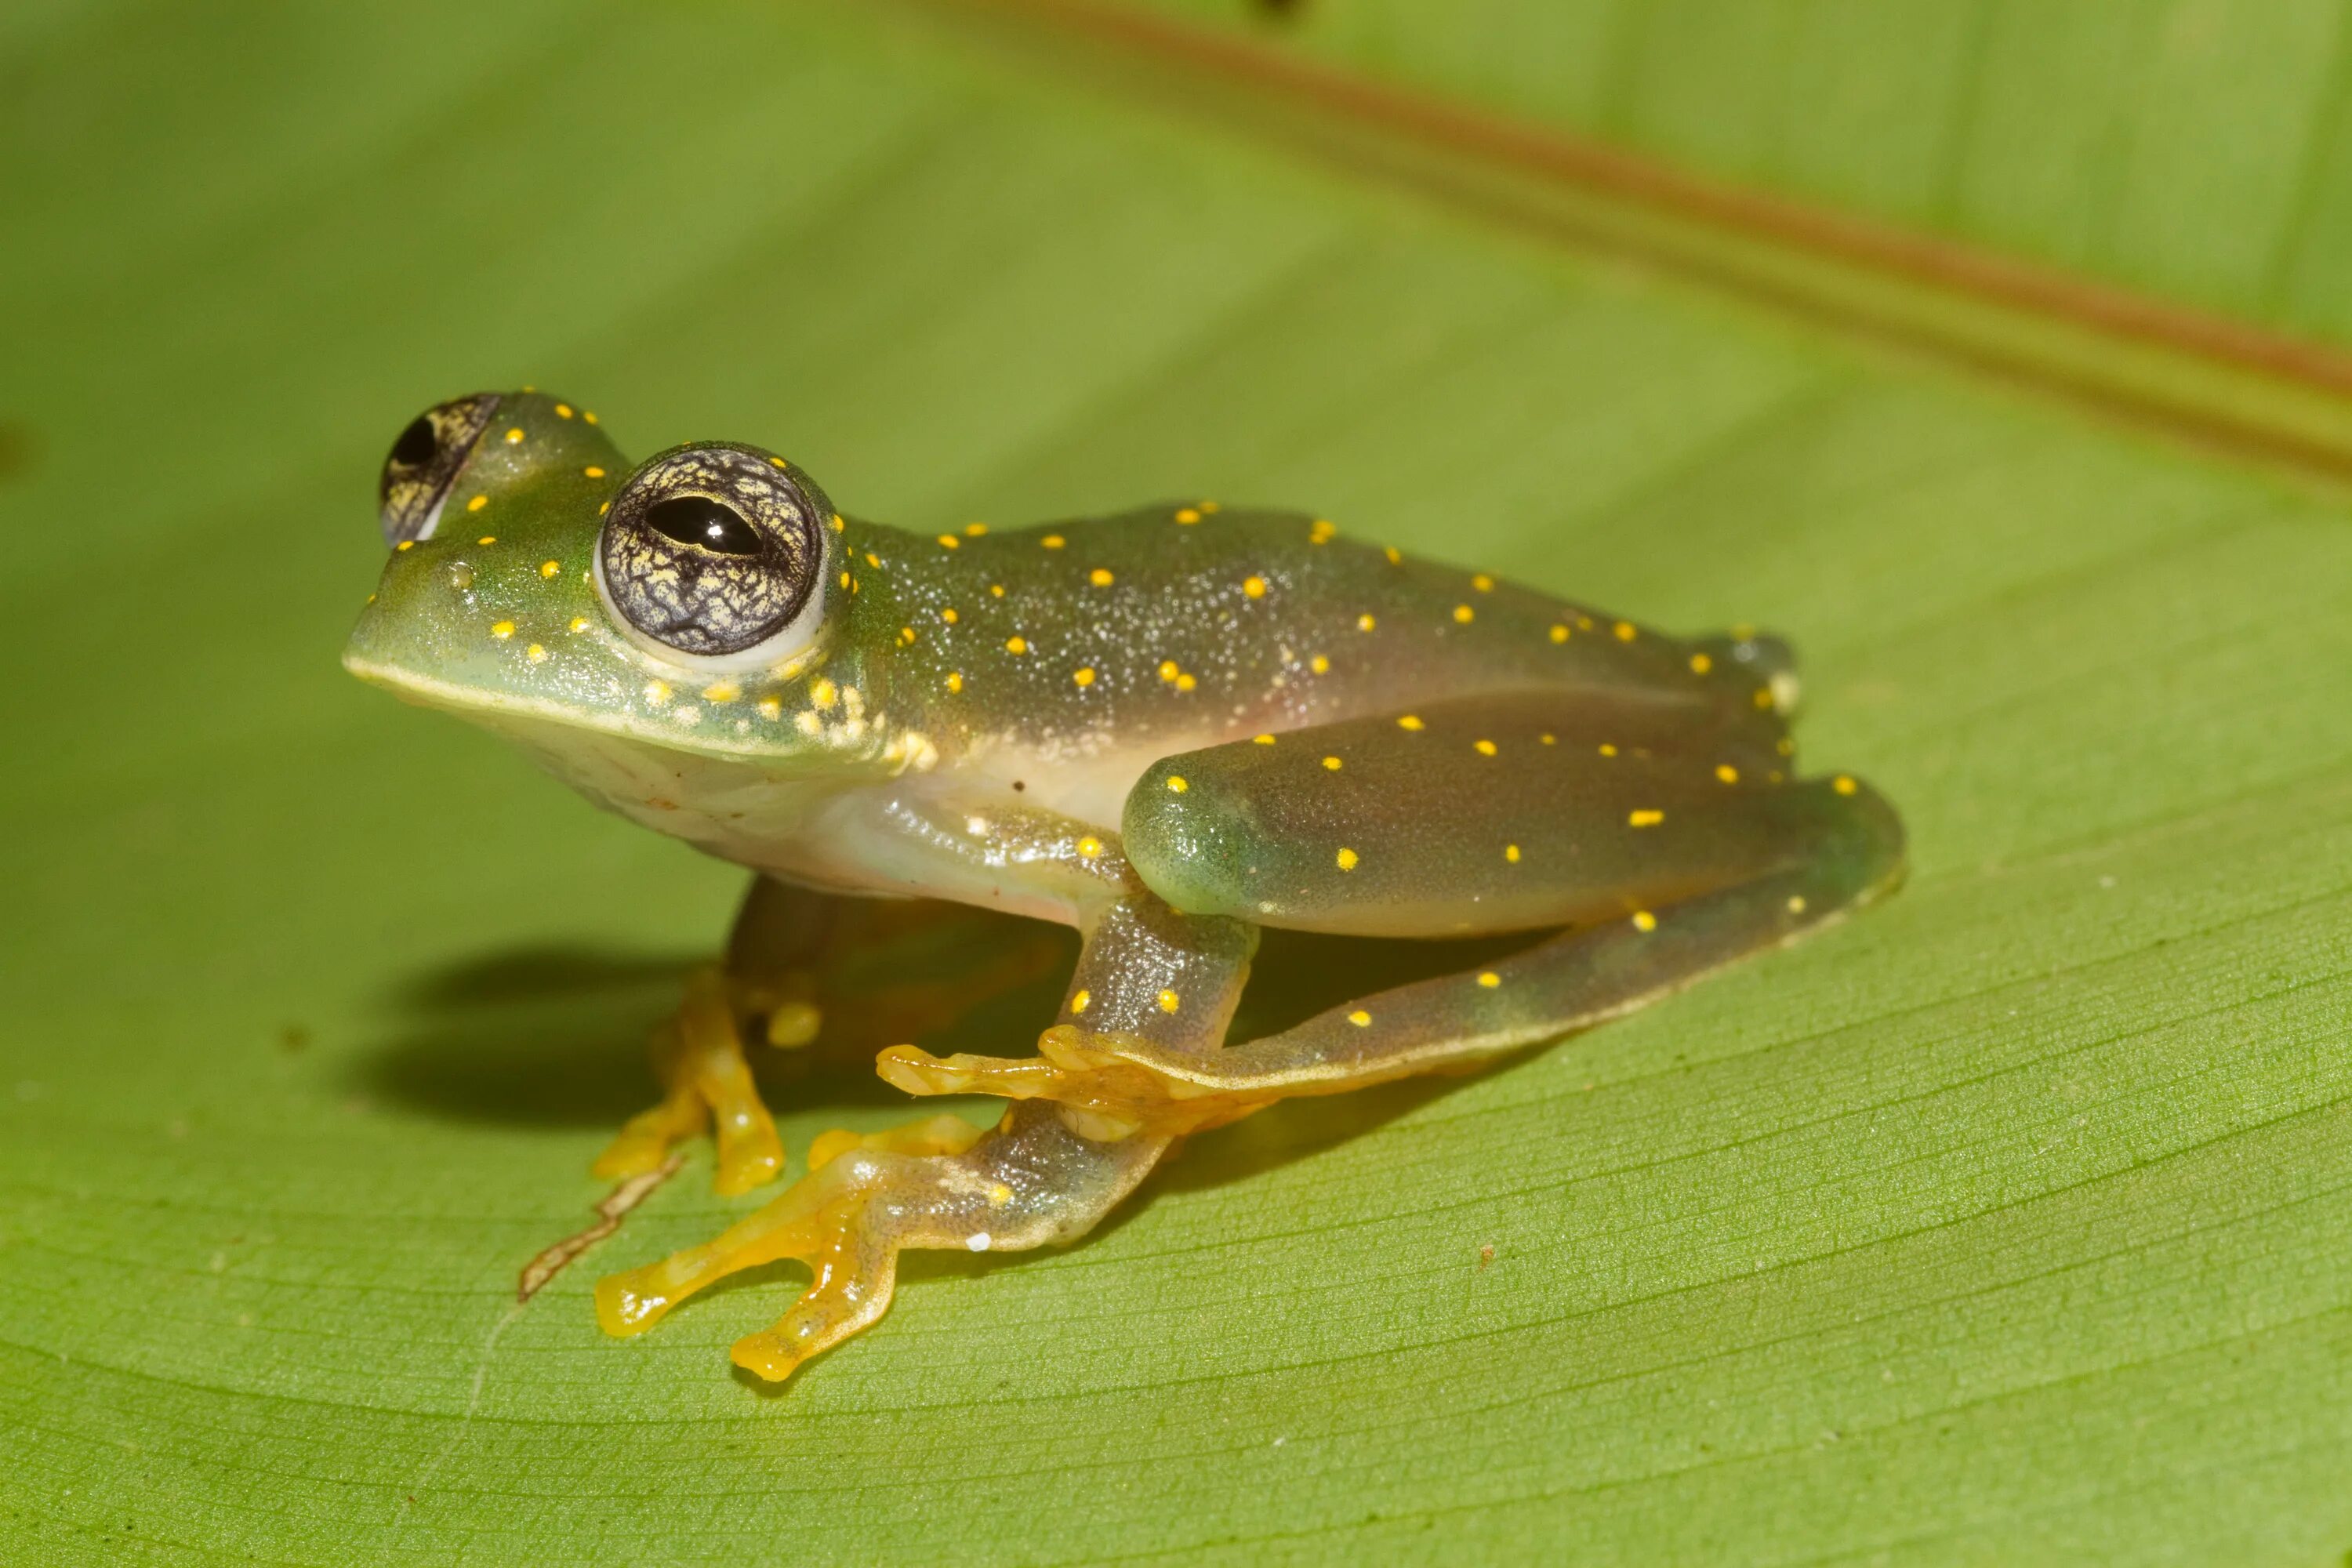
[1117,776,1903,1102]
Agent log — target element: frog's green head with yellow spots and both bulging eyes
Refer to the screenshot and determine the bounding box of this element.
[343,390,880,771]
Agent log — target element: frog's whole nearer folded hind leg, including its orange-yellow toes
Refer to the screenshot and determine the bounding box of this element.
[882,694,1903,1131]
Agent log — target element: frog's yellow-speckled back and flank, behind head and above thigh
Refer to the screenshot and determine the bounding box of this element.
[851,503,1769,774]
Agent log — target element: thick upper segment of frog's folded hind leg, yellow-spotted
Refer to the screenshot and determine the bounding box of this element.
[1124,691,1809,935]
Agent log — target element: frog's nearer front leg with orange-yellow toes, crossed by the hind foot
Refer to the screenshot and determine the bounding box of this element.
[597,813,1256,1380]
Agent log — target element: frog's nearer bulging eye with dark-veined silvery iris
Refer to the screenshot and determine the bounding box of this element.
[597,447,828,663]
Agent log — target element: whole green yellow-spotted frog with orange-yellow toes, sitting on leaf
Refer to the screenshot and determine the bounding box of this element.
[343,388,1905,1382]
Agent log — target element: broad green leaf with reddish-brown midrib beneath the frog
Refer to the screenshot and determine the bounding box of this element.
[0,0,2352,1563]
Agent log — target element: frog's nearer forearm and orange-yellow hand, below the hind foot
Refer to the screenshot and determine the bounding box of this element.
[597,1105,1169,1382]
